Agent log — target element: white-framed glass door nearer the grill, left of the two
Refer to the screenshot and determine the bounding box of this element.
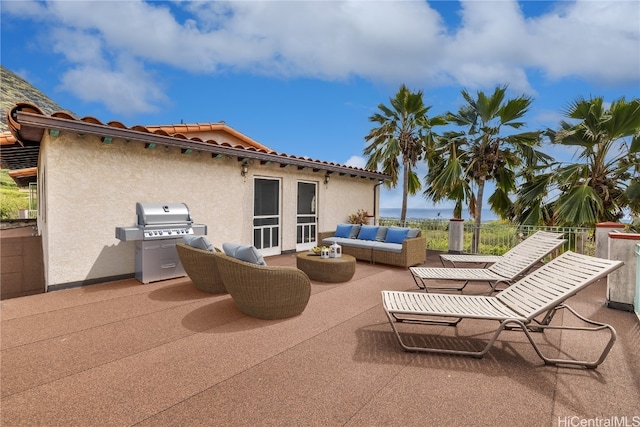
[253,178,282,256]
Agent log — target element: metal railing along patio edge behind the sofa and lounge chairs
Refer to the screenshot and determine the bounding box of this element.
[379,218,595,255]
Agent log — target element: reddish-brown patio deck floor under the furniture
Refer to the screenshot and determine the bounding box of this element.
[0,253,640,426]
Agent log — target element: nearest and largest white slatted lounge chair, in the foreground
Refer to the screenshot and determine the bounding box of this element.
[382,252,623,368]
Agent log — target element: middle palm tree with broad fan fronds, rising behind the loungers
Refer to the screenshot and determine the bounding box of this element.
[424,86,546,252]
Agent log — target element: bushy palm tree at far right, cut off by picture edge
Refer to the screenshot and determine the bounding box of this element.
[516,97,640,226]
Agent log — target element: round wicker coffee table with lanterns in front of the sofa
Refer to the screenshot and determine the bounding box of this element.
[296,252,356,283]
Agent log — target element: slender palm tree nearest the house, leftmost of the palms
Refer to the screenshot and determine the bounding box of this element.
[364,85,446,223]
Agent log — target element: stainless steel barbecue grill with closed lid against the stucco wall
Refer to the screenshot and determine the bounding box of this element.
[116,203,207,283]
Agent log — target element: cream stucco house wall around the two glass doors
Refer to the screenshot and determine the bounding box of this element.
[38,132,379,287]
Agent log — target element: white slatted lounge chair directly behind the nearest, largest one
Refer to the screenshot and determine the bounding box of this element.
[409,239,566,292]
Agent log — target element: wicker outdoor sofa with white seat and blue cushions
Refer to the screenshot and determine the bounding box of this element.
[318,224,427,267]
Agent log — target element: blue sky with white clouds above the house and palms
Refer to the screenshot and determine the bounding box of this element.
[0,0,640,208]
